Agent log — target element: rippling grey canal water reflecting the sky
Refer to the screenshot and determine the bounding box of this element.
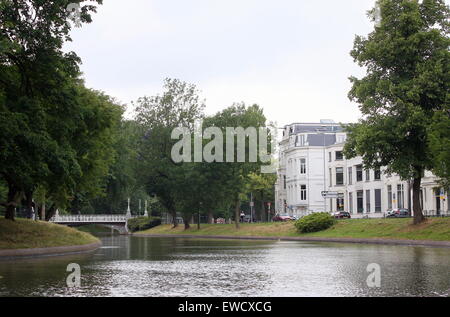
[0,236,450,297]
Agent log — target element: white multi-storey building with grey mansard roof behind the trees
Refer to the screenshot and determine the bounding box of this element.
[275,120,450,218]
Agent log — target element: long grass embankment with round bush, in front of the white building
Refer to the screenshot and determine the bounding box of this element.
[138,218,450,241]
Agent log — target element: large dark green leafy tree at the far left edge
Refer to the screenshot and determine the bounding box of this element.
[0,0,101,220]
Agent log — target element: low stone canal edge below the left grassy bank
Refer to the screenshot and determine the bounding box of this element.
[0,242,102,259]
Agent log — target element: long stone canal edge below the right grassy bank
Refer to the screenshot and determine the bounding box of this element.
[133,234,450,248]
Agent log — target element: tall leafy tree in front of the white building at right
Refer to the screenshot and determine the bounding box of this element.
[345,0,450,224]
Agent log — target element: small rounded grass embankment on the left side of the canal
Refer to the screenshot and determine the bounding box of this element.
[0,218,99,250]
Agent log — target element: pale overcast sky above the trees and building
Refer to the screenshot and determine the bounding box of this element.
[65,0,375,126]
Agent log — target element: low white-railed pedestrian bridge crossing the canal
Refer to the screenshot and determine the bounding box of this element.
[50,215,134,234]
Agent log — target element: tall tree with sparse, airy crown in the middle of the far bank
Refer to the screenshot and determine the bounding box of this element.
[136,79,204,228]
